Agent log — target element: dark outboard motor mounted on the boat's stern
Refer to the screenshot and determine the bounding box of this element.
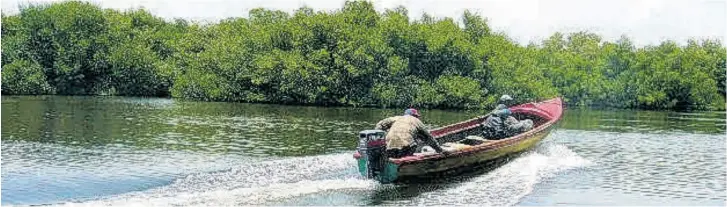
[358,130,387,178]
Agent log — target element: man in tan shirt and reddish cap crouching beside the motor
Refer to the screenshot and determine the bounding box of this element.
[376,109,447,158]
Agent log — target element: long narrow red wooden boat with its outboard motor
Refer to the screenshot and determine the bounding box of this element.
[353,97,563,184]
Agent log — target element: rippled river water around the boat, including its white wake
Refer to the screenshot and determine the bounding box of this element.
[2,96,727,206]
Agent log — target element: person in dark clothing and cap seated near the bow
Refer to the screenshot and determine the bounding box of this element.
[482,95,533,139]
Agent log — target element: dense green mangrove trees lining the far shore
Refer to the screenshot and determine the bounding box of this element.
[1,1,727,110]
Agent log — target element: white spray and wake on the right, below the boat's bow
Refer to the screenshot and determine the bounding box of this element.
[413,144,592,206]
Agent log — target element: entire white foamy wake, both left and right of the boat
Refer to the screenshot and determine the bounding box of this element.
[21,143,591,206]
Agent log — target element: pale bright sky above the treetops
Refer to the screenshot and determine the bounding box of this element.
[2,0,727,46]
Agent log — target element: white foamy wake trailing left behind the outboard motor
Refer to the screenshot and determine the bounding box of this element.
[41,153,376,206]
